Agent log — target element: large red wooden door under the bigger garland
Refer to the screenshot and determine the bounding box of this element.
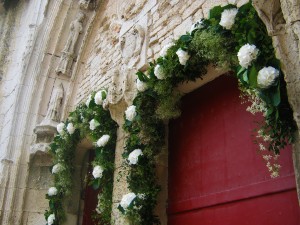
[167,76,300,225]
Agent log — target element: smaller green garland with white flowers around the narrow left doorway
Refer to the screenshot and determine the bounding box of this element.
[45,90,117,225]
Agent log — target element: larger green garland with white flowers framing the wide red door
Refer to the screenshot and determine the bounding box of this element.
[119,2,297,224]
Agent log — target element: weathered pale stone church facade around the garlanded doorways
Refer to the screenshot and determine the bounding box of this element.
[0,0,300,225]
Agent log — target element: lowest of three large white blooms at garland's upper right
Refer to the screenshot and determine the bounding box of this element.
[257,66,279,88]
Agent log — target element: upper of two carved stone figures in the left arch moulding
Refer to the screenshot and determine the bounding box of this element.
[55,12,85,76]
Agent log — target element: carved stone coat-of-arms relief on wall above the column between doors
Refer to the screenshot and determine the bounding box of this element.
[108,25,145,104]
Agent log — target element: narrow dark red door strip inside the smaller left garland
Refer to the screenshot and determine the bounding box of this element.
[82,150,99,225]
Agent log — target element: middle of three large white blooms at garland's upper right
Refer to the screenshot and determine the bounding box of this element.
[237,44,259,68]
